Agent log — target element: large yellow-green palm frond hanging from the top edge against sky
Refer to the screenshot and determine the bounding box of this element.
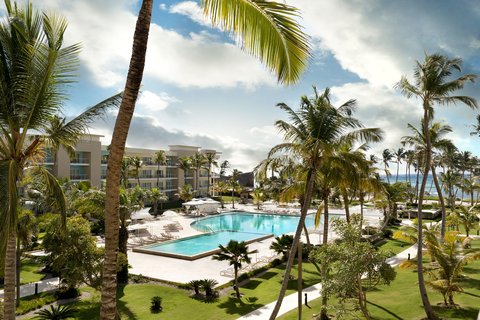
[202,0,310,84]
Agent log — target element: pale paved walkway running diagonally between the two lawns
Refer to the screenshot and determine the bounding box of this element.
[238,245,417,320]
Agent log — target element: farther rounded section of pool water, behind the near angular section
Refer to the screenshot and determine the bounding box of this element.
[191,211,314,236]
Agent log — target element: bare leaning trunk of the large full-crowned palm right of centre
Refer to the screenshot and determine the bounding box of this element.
[270,171,315,320]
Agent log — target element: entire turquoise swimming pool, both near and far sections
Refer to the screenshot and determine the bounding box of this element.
[133,211,332,260]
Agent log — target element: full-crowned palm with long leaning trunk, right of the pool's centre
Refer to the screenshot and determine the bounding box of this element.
[268,87,381,320]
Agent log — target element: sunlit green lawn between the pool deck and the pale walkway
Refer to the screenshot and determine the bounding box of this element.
[25,263,319,320]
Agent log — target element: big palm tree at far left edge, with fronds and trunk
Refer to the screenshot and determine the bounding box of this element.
[0,1,119,320]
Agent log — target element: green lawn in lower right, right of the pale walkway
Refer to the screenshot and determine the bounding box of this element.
[279,240,480,320]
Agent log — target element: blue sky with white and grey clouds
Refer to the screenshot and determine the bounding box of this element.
[2,0,480,172]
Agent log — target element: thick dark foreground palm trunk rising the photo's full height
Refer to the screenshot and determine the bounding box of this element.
[100,0,152,320]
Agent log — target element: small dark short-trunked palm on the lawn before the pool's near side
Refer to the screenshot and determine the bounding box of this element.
[212,240,258,299]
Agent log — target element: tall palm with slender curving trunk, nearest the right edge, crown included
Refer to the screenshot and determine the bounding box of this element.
[396,54,477,320]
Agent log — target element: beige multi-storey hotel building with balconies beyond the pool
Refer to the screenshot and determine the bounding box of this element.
[44,134,220,198]
